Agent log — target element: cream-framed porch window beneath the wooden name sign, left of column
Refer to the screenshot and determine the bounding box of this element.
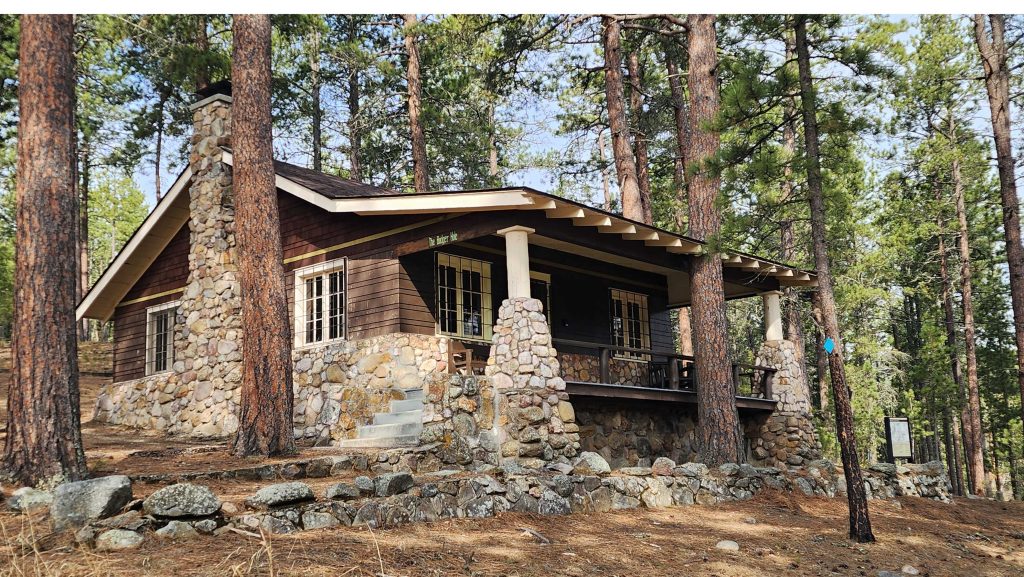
[434,252,493,341]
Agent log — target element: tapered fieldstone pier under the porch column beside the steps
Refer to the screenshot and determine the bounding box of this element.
[485,297,580,467]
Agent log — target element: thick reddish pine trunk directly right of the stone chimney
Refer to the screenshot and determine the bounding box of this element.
[231,14,295,455]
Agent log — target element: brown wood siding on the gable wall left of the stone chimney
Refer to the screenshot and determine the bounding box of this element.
[113,222,188,381]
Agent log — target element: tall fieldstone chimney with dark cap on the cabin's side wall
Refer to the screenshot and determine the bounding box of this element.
[173,82,242,436]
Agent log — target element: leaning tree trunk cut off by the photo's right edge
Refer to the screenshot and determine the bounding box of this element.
[974,14,1024,428]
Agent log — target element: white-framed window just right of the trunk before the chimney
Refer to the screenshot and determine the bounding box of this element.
[295,258,346,346]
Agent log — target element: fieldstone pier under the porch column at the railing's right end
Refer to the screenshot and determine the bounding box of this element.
[751,340,821,468]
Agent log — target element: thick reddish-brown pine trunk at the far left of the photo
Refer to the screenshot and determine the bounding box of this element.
[3,15,88,485]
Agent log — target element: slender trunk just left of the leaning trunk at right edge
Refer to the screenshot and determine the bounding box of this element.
[951,150,985,495]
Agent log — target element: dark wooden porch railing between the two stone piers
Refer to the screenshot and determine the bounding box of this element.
[552,338,775,400]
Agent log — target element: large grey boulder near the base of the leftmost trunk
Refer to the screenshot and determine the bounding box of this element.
[50,475,131,531]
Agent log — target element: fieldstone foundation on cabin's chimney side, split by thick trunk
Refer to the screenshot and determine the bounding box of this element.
[94,333,447,443]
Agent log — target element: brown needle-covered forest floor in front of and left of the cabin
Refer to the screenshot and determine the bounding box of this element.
[0,349,1024,577]
